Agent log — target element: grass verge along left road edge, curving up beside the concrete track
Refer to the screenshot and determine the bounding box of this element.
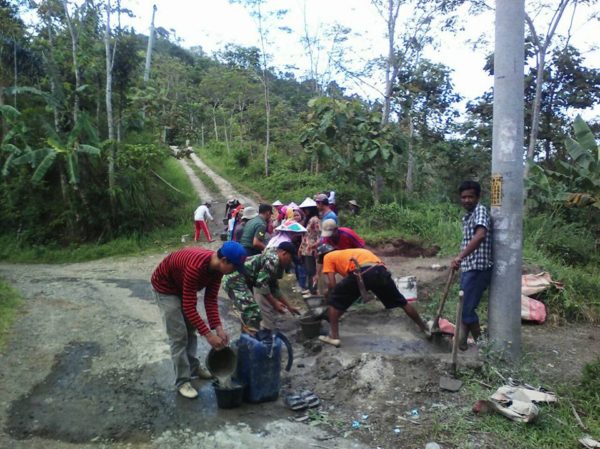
[0,158,198,263]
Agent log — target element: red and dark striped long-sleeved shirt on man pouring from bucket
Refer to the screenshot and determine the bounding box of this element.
[150,247,223,335]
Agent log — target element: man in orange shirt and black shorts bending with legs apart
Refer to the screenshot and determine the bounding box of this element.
[317,245,429,347]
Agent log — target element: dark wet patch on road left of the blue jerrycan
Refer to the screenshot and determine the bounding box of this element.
[5,342,270,443]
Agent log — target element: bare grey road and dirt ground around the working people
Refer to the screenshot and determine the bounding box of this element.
[0,155,600,449]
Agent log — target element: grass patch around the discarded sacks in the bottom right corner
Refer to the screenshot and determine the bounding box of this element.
[433,359,600,449]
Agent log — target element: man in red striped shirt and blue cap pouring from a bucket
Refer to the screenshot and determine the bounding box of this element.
[151,242,246,399]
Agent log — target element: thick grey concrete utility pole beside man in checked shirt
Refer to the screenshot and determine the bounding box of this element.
[489,0,525,360]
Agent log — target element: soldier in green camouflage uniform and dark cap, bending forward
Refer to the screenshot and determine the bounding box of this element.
[223,242,300,329]
